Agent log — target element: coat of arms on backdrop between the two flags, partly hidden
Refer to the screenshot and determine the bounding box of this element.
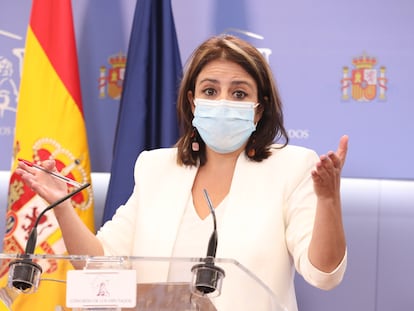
[99,52,126,99]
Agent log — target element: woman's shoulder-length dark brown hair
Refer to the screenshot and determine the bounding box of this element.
[176,35,289,165]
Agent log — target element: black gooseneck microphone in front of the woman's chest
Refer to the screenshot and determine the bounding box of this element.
[191,189,225,297]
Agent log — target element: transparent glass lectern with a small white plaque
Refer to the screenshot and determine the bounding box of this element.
[0,254,286,311]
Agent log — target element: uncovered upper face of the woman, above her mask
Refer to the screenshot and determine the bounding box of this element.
[188,59,262,123]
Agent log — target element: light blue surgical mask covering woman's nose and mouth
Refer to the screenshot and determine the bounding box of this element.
[193,98,258,153]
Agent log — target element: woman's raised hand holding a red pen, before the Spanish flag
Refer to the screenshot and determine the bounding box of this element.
[15,160,68,204]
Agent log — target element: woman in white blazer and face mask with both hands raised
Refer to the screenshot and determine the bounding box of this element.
[18,35,348,310]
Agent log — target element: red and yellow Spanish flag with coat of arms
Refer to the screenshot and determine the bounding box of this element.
[0,0,95,311]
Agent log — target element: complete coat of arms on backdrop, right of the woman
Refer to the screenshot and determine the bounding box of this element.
[341,54,387,102]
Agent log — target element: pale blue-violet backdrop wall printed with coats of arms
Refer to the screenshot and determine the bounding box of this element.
[0,0,414,179]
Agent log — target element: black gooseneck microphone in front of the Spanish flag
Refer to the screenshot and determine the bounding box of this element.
[8,183,90,293]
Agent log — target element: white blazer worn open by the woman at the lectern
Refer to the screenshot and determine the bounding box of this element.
[97,146,346,311]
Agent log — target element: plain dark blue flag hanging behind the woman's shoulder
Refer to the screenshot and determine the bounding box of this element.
[103,0,182,222]
